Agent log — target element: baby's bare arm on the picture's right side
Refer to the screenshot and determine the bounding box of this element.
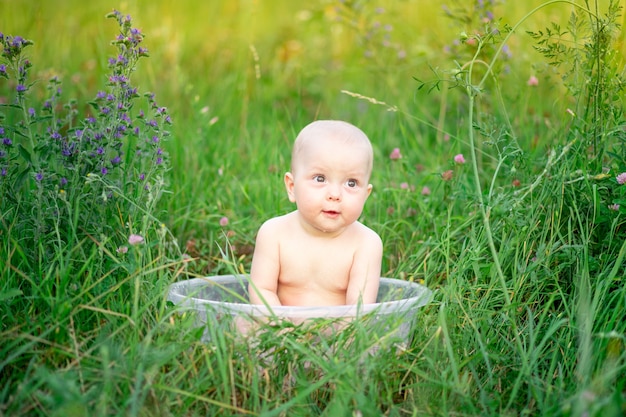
[346,230,383,304]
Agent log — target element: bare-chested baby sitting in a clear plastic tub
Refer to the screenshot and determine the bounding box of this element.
[249,120,383,306]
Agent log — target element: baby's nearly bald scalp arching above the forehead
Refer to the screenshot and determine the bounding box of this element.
[291,120,374,179]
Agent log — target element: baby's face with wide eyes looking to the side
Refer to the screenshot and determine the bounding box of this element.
[285,138,372,234]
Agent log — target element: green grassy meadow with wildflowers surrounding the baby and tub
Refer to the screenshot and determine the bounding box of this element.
[0,0,626,416]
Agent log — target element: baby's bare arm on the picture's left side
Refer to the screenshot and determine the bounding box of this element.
[248,220,281,306]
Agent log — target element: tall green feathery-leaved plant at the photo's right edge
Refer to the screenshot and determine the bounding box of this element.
[528,0,626,265]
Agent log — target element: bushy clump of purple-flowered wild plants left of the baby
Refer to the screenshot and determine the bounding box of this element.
[0,11,171,270]
